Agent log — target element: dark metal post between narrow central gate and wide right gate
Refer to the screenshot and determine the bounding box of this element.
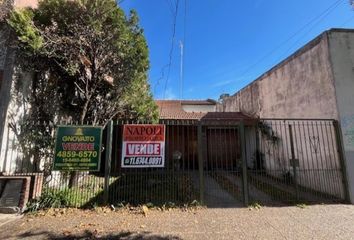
[239,121,249,207]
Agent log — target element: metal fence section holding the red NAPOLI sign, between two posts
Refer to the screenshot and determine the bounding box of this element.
[109,121,200,205]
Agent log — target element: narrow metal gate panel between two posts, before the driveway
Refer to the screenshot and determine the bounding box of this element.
[201,123,244,207]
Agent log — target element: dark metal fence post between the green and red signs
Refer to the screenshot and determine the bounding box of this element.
[103,120,113,205]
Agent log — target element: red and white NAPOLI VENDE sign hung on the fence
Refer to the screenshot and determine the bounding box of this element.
[121,124,165,168]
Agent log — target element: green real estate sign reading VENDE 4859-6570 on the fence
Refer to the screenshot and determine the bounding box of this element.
[53,126,102,171]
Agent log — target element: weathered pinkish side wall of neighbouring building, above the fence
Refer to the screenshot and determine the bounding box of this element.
[218,34,338,119]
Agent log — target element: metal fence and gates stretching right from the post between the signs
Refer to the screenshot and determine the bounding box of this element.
[105,119,347,207]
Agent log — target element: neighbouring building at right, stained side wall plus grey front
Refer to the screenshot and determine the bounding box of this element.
[217,29,354,203]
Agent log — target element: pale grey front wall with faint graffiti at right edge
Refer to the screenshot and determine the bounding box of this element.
[329,30,354,203]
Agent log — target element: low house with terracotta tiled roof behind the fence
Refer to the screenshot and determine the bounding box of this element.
[156,99,255,170]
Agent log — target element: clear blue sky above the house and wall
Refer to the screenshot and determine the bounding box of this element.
[120,0,354,100]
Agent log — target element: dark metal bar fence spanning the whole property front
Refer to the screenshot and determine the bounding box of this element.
[1,119,348,207]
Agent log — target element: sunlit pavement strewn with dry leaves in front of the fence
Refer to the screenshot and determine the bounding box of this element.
[0,205,354,240]
